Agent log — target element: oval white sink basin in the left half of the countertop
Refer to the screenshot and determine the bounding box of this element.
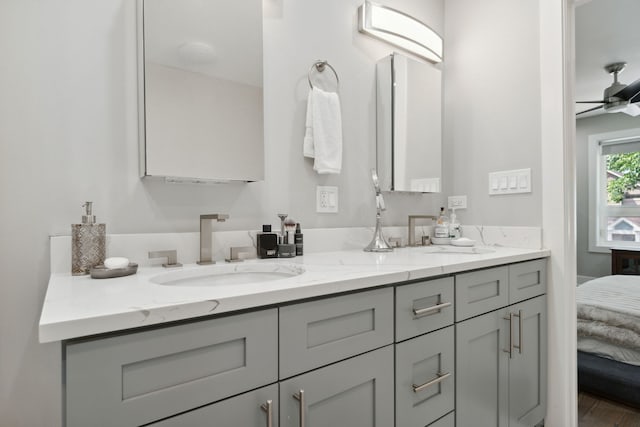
[151,263,304,287]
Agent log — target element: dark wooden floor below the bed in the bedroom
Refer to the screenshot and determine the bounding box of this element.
[578,392,640,427]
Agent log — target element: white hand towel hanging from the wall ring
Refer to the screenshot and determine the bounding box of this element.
[304,88,342,174]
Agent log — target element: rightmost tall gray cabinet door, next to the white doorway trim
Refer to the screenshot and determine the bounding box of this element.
[509,295,547,427]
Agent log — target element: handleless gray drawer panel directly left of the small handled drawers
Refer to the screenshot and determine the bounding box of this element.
[280,288,393,378]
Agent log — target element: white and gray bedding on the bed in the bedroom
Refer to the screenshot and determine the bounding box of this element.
[576,275,640,364]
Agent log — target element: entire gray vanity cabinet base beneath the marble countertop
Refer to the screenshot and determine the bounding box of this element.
[63,260,546,427]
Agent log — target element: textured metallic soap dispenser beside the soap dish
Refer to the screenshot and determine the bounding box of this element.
[71,202,106,276]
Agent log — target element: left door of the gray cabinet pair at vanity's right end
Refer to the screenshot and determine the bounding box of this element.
[456,309,509,427]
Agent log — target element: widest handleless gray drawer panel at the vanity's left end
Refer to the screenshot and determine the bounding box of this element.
[66,309,278,427]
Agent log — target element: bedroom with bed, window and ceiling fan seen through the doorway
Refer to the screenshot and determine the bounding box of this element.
[575,0,640,427]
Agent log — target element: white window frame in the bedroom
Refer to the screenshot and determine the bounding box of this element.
[588,128,640,253]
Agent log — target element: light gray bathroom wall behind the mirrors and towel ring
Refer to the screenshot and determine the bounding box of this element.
[0,0,444,427]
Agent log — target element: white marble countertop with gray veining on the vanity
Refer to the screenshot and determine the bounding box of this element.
[39,247,550,343]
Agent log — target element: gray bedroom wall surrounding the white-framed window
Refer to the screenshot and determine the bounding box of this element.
[576,113,640,277]
